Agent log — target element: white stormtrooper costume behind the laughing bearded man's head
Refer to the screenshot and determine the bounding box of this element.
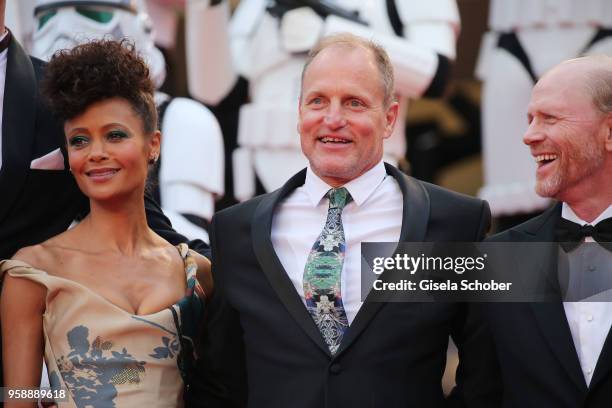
[477,0,612,217]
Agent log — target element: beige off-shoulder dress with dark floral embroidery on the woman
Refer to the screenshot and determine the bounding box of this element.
[0,244,204,408]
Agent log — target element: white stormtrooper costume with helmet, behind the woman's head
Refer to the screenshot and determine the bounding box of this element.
[32,0,224,242]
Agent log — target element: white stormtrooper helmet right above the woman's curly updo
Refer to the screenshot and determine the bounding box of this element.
[32,0,166,88]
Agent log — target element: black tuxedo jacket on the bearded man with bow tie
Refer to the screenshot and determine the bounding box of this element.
[485,203,612,408]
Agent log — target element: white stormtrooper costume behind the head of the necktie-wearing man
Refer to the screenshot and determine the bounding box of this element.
[186,0,459,200]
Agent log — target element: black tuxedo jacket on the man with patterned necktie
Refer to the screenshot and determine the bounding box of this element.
[196,165,498,408]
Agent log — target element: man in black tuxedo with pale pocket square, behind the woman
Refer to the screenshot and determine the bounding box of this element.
[0,0,209,384]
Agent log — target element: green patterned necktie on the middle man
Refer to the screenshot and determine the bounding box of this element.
[304,187,351,355]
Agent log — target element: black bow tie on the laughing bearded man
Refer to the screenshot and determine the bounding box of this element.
[555,218,612,252]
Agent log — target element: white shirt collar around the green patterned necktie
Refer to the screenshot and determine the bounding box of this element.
[304,160,387,207]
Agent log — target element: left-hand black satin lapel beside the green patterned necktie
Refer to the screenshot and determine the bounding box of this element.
[252,171,330,355]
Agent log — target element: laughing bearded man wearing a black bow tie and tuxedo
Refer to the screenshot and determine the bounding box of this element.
[488,56,612,408]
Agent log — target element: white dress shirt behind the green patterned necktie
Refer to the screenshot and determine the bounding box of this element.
[272,161,403,324]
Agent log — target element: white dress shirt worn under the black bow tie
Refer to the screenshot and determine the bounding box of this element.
[561,203,612,385]
